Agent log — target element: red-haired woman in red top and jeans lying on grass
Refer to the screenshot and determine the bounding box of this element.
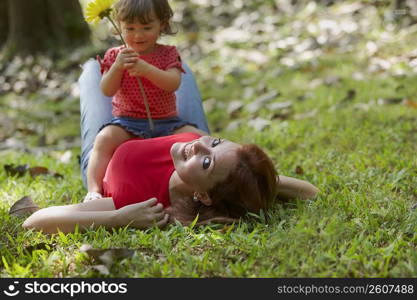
[23,61,317,233]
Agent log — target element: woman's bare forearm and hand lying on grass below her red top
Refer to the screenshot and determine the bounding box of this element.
[23,198,168,233]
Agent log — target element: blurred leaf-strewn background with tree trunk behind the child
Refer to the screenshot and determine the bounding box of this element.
[0,0,417,149]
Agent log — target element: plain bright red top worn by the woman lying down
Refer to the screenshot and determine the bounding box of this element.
[103,132,200,209]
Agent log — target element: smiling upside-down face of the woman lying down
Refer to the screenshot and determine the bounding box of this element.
[171,136,241,192]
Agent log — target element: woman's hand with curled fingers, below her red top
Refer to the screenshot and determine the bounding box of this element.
[116,198,169,229]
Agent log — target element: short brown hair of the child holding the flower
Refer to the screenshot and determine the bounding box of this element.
[114,0,175,34]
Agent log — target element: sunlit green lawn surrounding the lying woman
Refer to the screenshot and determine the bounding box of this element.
[0,0,417,277]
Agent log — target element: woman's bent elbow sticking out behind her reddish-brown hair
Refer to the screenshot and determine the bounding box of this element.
[277,175,319,200]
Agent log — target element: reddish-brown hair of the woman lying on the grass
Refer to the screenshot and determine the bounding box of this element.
[167,144,278,225]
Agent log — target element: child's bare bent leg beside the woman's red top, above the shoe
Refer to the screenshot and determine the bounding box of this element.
[87,125,133,194]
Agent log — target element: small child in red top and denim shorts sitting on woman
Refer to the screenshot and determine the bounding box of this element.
[84,0,205,201]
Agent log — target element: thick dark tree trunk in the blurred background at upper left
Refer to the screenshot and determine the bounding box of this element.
[4,0,90,54]
